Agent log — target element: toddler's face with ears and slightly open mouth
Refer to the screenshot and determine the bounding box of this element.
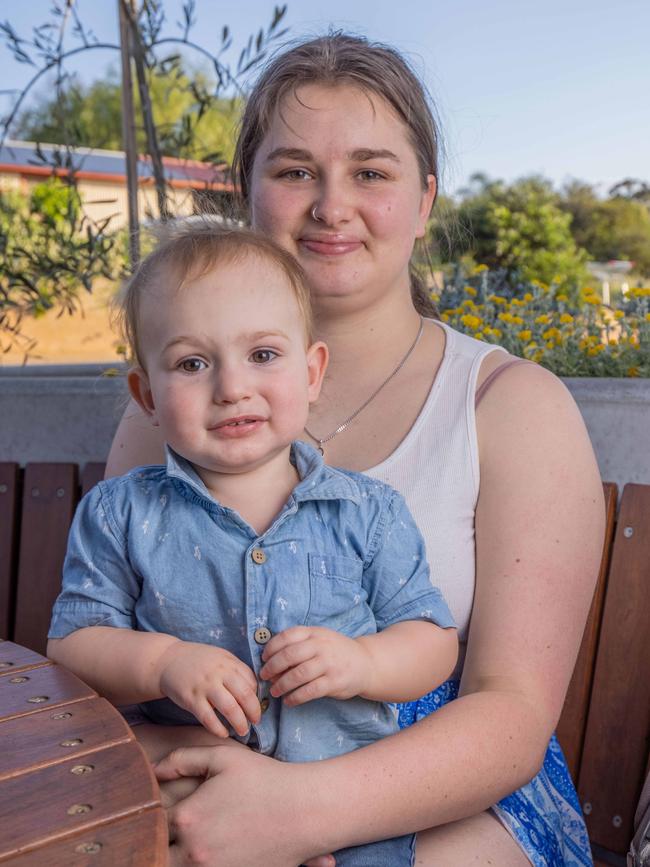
[129,254,327,482]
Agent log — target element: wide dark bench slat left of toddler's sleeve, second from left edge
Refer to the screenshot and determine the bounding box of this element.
[14,464,78,653]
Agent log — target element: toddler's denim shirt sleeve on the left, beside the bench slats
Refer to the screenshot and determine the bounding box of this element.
[48,483,140,638]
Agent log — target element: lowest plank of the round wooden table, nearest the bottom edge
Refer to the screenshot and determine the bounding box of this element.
[2,807,167,867]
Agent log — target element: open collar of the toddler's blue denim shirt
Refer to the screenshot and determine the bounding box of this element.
[165,440,361,508]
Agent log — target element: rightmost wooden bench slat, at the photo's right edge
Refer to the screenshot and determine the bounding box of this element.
[578,485,650,854]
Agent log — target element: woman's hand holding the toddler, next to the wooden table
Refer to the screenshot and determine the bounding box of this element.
[154,746,335,867]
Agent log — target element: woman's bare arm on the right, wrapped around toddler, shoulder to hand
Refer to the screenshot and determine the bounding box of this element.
[151,365,604,867]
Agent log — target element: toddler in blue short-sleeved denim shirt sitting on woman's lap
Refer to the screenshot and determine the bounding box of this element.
[48,223,457,867]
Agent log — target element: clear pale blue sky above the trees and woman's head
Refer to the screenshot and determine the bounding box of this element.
[0,0,650,195]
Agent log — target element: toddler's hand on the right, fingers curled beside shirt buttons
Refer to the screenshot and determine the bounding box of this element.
[260,626,372,706]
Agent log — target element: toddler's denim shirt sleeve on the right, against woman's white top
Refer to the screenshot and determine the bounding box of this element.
[363,489,456,630]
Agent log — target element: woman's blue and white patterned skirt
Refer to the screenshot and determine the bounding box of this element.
[397,680,593,867]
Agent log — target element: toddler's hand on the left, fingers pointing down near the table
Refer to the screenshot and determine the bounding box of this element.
[158,641,262,738]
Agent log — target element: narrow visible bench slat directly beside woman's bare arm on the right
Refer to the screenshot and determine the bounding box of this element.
[557,482,618,780]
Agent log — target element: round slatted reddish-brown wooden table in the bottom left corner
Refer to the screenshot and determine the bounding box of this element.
[0,641,167,867]
